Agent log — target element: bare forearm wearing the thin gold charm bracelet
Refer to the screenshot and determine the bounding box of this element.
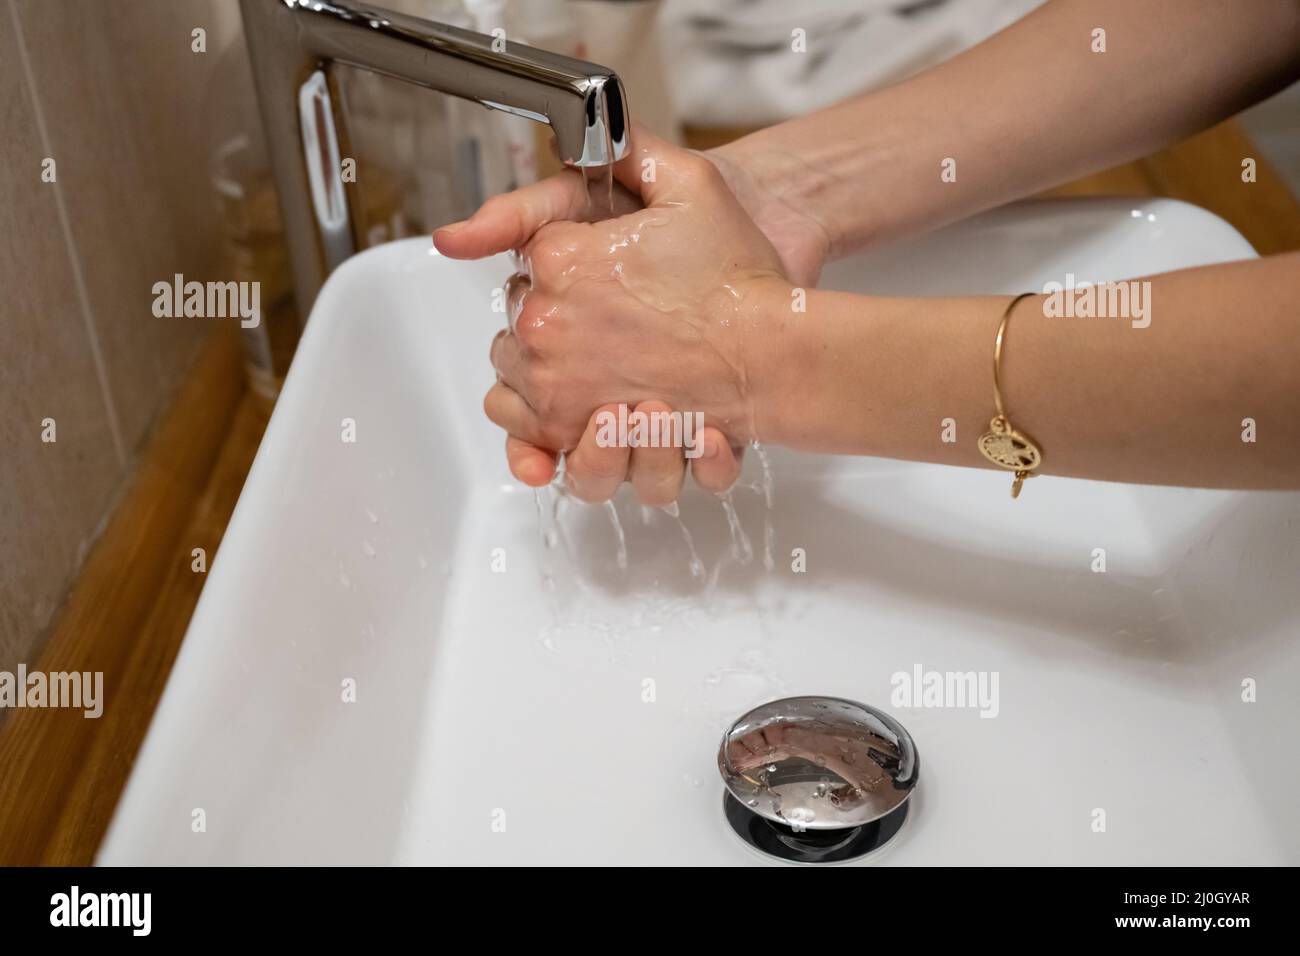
[754,254,1300,488]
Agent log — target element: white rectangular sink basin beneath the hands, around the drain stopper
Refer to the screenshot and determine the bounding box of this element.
[99,200,1300,865]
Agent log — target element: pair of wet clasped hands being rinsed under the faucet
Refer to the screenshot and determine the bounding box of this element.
[434,127,827,506]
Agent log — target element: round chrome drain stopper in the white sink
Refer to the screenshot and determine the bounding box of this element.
[718,697,920,864]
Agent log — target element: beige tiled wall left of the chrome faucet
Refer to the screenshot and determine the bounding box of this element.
[0,0,251,670]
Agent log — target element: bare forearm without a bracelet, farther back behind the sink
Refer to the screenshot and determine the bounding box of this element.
[718,0,1300,258]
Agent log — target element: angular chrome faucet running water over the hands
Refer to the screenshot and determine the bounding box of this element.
[241,0,628,321]
